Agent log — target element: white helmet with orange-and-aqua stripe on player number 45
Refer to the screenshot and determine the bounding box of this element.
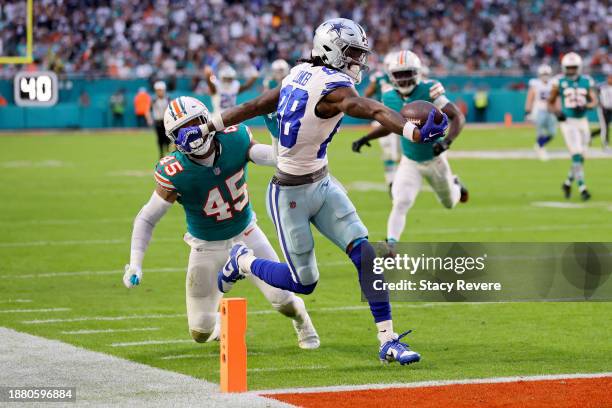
[164,96,215,155]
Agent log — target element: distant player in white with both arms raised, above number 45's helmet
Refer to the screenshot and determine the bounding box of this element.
[204,65,258,112]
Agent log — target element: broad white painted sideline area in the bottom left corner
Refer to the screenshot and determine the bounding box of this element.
[0,327,291,408]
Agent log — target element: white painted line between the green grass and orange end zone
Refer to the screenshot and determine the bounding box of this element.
[251,372,612,395]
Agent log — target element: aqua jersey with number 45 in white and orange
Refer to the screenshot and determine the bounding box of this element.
[154,125,253,241]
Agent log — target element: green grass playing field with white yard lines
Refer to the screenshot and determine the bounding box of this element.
[0,128,612,389]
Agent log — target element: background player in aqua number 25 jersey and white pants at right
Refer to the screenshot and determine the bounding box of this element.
[548,52,597,201]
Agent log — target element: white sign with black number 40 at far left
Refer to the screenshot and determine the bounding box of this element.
[13,71,58,106]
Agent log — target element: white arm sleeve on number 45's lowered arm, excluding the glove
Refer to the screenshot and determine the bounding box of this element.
[130,192,172,270]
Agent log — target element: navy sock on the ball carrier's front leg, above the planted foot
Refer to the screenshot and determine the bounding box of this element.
[348,239,391,323]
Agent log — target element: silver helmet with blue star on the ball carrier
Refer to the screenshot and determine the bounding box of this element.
[312,18,370,83]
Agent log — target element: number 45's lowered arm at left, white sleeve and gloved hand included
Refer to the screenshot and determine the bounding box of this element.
[123,185,177,288]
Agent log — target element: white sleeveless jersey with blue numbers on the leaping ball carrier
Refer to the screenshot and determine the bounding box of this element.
[276,63,355,175]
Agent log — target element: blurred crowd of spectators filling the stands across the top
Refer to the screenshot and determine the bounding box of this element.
[0,0,612,78]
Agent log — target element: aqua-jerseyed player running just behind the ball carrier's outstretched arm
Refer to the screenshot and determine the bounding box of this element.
[353,50,468,249]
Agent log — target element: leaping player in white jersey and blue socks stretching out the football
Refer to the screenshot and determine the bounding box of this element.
[179,18,448,364]
